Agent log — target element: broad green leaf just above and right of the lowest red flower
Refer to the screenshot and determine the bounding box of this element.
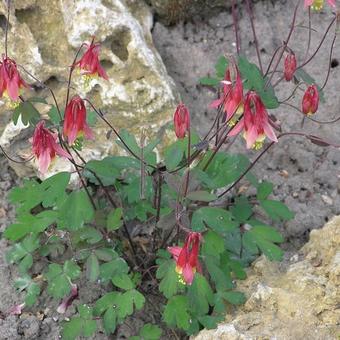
[191,207,238,235]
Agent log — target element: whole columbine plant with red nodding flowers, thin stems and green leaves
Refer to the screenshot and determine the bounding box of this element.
[0,0,340,339]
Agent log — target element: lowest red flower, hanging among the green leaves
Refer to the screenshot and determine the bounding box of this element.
[168,232,202,285]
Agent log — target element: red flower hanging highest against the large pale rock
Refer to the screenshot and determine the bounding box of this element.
[74,40,109,80]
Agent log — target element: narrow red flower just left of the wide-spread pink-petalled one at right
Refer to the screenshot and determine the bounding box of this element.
[210,61,243,124]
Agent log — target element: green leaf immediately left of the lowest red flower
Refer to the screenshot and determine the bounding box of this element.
[156,260,181,299]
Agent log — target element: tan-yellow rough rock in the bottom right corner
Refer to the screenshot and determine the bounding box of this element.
[194,216,340,340]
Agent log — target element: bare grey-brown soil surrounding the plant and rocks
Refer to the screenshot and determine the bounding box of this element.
[0,0,340,340]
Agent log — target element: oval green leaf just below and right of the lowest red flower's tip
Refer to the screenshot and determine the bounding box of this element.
[188,273,213,315]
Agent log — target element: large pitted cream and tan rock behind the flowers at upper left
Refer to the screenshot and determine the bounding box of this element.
[0,0,179,175]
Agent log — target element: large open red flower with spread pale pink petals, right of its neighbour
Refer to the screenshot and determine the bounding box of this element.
[229,91,277,150]
